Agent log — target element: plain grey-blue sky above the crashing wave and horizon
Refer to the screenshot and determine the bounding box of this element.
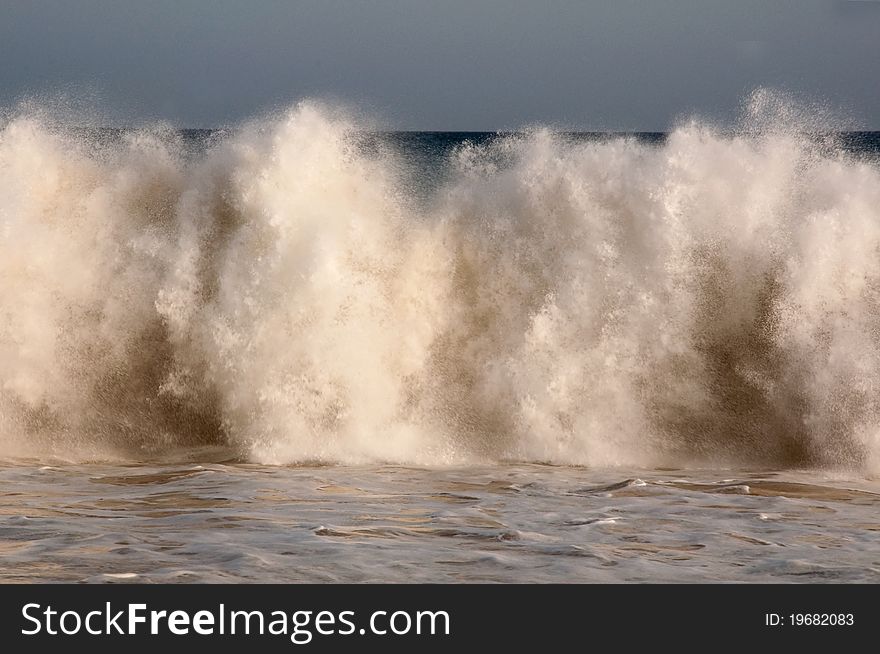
[0,0,880,130]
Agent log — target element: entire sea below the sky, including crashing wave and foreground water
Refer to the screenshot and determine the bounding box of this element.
[0,91,880,582]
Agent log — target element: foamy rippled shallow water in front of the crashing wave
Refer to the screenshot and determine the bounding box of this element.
[0,464,880,583]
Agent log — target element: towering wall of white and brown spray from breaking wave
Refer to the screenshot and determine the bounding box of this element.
[0,93,880,468]
